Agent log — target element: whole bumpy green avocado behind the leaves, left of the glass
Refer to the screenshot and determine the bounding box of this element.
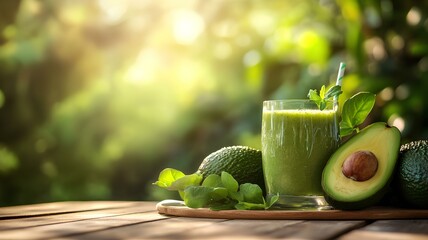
[197,146,265,192]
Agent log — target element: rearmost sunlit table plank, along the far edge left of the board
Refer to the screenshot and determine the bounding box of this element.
[0,201,145,220]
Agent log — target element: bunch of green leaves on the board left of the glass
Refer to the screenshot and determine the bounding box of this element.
[153,168,279,210]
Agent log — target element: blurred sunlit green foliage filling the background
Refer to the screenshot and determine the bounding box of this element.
[0,0,428,206]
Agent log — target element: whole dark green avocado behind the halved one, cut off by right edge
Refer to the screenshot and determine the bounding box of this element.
[394,140,428,209]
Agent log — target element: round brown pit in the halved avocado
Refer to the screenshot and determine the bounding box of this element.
[342,151,378,182]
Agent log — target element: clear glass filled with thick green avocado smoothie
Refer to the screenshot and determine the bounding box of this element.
[262,100,339,205]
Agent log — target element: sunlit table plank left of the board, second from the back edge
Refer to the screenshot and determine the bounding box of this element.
[0,203,155,234]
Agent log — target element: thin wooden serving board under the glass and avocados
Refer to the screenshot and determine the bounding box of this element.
[156,200,428,220]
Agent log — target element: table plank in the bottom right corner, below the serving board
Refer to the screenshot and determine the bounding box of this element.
[340,219,428,240]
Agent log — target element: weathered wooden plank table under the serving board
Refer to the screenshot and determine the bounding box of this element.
[0,201,428,240]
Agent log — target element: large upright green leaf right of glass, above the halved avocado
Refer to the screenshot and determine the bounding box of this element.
[340,92,376,137]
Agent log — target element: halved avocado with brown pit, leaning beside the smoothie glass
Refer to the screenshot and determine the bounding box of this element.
[321,122,401,210]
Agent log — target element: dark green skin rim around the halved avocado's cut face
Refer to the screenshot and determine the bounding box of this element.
[322,122,401,210]
